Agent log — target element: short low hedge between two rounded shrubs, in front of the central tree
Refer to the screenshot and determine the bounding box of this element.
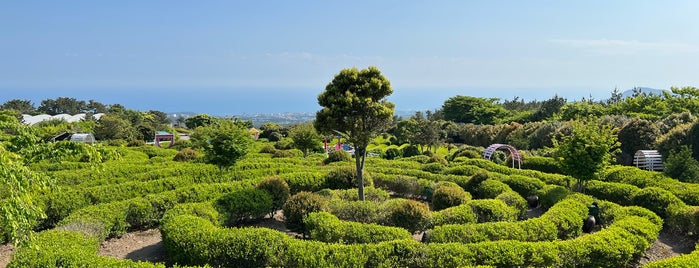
[304,212,412,244]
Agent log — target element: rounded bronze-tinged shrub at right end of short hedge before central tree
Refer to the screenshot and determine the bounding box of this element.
[386,199,431,233]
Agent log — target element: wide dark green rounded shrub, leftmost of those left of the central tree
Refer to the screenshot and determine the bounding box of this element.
[216,189,272,226]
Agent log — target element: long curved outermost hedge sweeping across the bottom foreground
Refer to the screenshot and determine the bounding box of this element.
[161,209,661,267]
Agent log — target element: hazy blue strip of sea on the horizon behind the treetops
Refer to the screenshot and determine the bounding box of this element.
[0,86,612,116]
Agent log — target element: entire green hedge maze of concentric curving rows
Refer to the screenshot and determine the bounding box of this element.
[5,142,699,267]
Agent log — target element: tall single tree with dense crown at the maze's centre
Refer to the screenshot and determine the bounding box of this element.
[315,66,394,200]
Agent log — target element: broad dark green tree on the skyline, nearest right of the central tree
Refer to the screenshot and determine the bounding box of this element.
[442,95,507,125]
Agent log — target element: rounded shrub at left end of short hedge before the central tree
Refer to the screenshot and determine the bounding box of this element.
[282,192,328,235]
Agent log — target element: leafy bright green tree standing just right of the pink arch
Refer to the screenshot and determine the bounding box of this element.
[554,118,619,190]
